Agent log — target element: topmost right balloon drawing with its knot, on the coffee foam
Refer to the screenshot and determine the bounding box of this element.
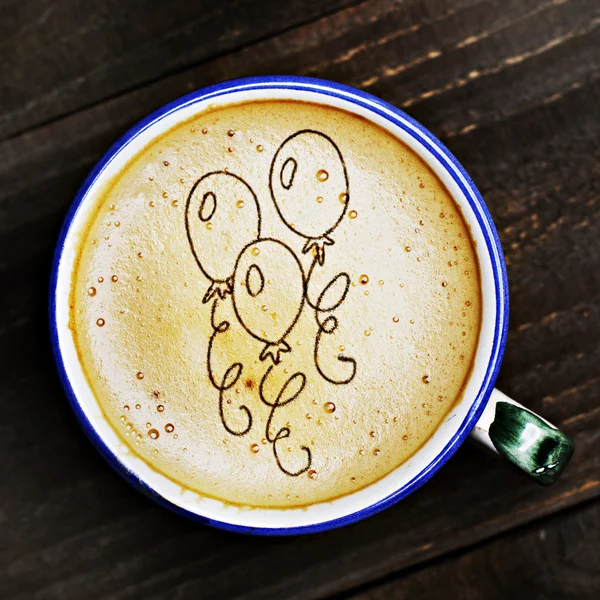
[269,129,350,265]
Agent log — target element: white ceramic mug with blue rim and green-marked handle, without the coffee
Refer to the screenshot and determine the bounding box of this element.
[50,76,573,535]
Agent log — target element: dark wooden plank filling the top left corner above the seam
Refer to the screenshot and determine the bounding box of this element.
[0,0,357,139]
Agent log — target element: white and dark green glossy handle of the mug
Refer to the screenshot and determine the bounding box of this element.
[471,390,575,485]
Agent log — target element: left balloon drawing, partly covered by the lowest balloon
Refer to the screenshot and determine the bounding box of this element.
[185,171,260,303]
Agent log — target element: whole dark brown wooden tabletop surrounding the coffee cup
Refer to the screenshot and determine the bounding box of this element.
[0,0,600,600]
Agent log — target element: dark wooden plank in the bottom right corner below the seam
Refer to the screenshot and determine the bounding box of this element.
[348,502,600,600]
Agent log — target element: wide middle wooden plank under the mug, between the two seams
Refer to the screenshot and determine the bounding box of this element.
[0,0,600,599]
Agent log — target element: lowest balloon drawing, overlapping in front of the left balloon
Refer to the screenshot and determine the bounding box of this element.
[233,238,304,364]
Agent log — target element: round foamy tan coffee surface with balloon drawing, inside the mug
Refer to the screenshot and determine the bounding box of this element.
[70,101,482,507]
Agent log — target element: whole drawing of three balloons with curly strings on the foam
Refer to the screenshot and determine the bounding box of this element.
[185,129,357,477]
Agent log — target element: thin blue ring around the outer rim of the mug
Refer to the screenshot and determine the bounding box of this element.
[49,75,508,536]
